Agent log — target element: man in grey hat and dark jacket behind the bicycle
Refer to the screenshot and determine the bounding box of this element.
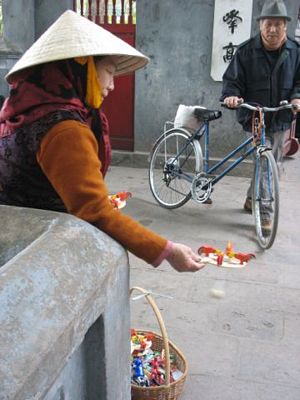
[221,0,300,216]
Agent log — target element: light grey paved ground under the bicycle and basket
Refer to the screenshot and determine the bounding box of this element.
[107,154,300,400]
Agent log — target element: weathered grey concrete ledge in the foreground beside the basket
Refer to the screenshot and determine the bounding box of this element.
[0,206,130,400]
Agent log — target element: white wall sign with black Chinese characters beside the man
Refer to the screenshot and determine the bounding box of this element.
[210,0,253,81]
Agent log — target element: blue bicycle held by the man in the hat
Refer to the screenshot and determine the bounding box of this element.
[149,102,297,249]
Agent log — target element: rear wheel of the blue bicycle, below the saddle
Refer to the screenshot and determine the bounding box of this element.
[149,129,203,209]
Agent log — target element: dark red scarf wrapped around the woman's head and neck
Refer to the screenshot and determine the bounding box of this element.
[0,60,111,175]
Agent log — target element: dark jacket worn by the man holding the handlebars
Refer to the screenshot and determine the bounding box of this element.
[221,34,300,132]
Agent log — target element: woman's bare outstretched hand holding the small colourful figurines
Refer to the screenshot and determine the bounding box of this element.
[166,243,205,272]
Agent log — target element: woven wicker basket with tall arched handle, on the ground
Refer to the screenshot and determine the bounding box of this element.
[130,286,188,400]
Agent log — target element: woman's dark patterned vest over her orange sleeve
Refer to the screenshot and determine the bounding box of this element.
[0,111,82,212]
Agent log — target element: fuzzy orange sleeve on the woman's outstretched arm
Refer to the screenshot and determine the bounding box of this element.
[37,121,168,265]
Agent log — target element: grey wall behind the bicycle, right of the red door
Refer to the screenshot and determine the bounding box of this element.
[135,0,300,157]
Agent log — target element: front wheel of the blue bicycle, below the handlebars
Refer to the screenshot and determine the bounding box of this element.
[252,150,279,249]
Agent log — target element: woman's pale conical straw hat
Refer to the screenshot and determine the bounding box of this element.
[5,10,149,83]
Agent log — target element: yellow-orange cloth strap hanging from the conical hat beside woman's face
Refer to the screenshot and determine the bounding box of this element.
[75,56,103,108]
